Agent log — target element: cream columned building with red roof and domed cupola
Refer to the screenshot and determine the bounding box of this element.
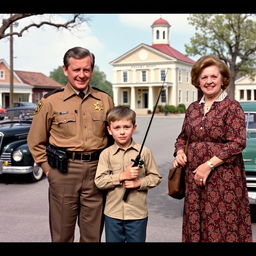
[110,18,198,114]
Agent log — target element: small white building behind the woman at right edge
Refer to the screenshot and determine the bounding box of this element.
[235,76,256,102]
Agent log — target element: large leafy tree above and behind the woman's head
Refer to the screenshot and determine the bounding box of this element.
[185,13,256,98]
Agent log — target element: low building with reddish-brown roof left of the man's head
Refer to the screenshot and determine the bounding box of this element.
[0,59,63,108]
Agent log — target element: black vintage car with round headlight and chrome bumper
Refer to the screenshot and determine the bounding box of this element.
[0,107,44,181]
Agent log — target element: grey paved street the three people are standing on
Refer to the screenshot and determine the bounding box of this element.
[0,116,256,242]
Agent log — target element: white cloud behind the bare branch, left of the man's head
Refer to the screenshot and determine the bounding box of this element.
[0,15,104,75]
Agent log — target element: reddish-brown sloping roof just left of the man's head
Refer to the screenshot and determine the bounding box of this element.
[15,70,63,88]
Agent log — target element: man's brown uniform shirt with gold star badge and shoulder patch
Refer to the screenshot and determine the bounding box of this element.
[28,83,113,163]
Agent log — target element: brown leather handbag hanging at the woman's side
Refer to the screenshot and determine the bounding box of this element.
[168,141,188,199]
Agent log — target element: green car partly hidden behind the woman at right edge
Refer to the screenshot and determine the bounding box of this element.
[240,102,256,204]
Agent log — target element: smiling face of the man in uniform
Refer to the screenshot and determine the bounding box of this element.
[63,56,93,91]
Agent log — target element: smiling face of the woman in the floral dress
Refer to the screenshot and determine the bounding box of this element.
[199,65,223,98]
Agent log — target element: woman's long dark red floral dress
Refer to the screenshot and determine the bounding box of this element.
[175,96,252,242]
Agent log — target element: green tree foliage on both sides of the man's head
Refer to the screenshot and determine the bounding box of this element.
[50,65,113,96]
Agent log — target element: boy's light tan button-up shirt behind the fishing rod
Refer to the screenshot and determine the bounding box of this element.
[95,141,162,220]
